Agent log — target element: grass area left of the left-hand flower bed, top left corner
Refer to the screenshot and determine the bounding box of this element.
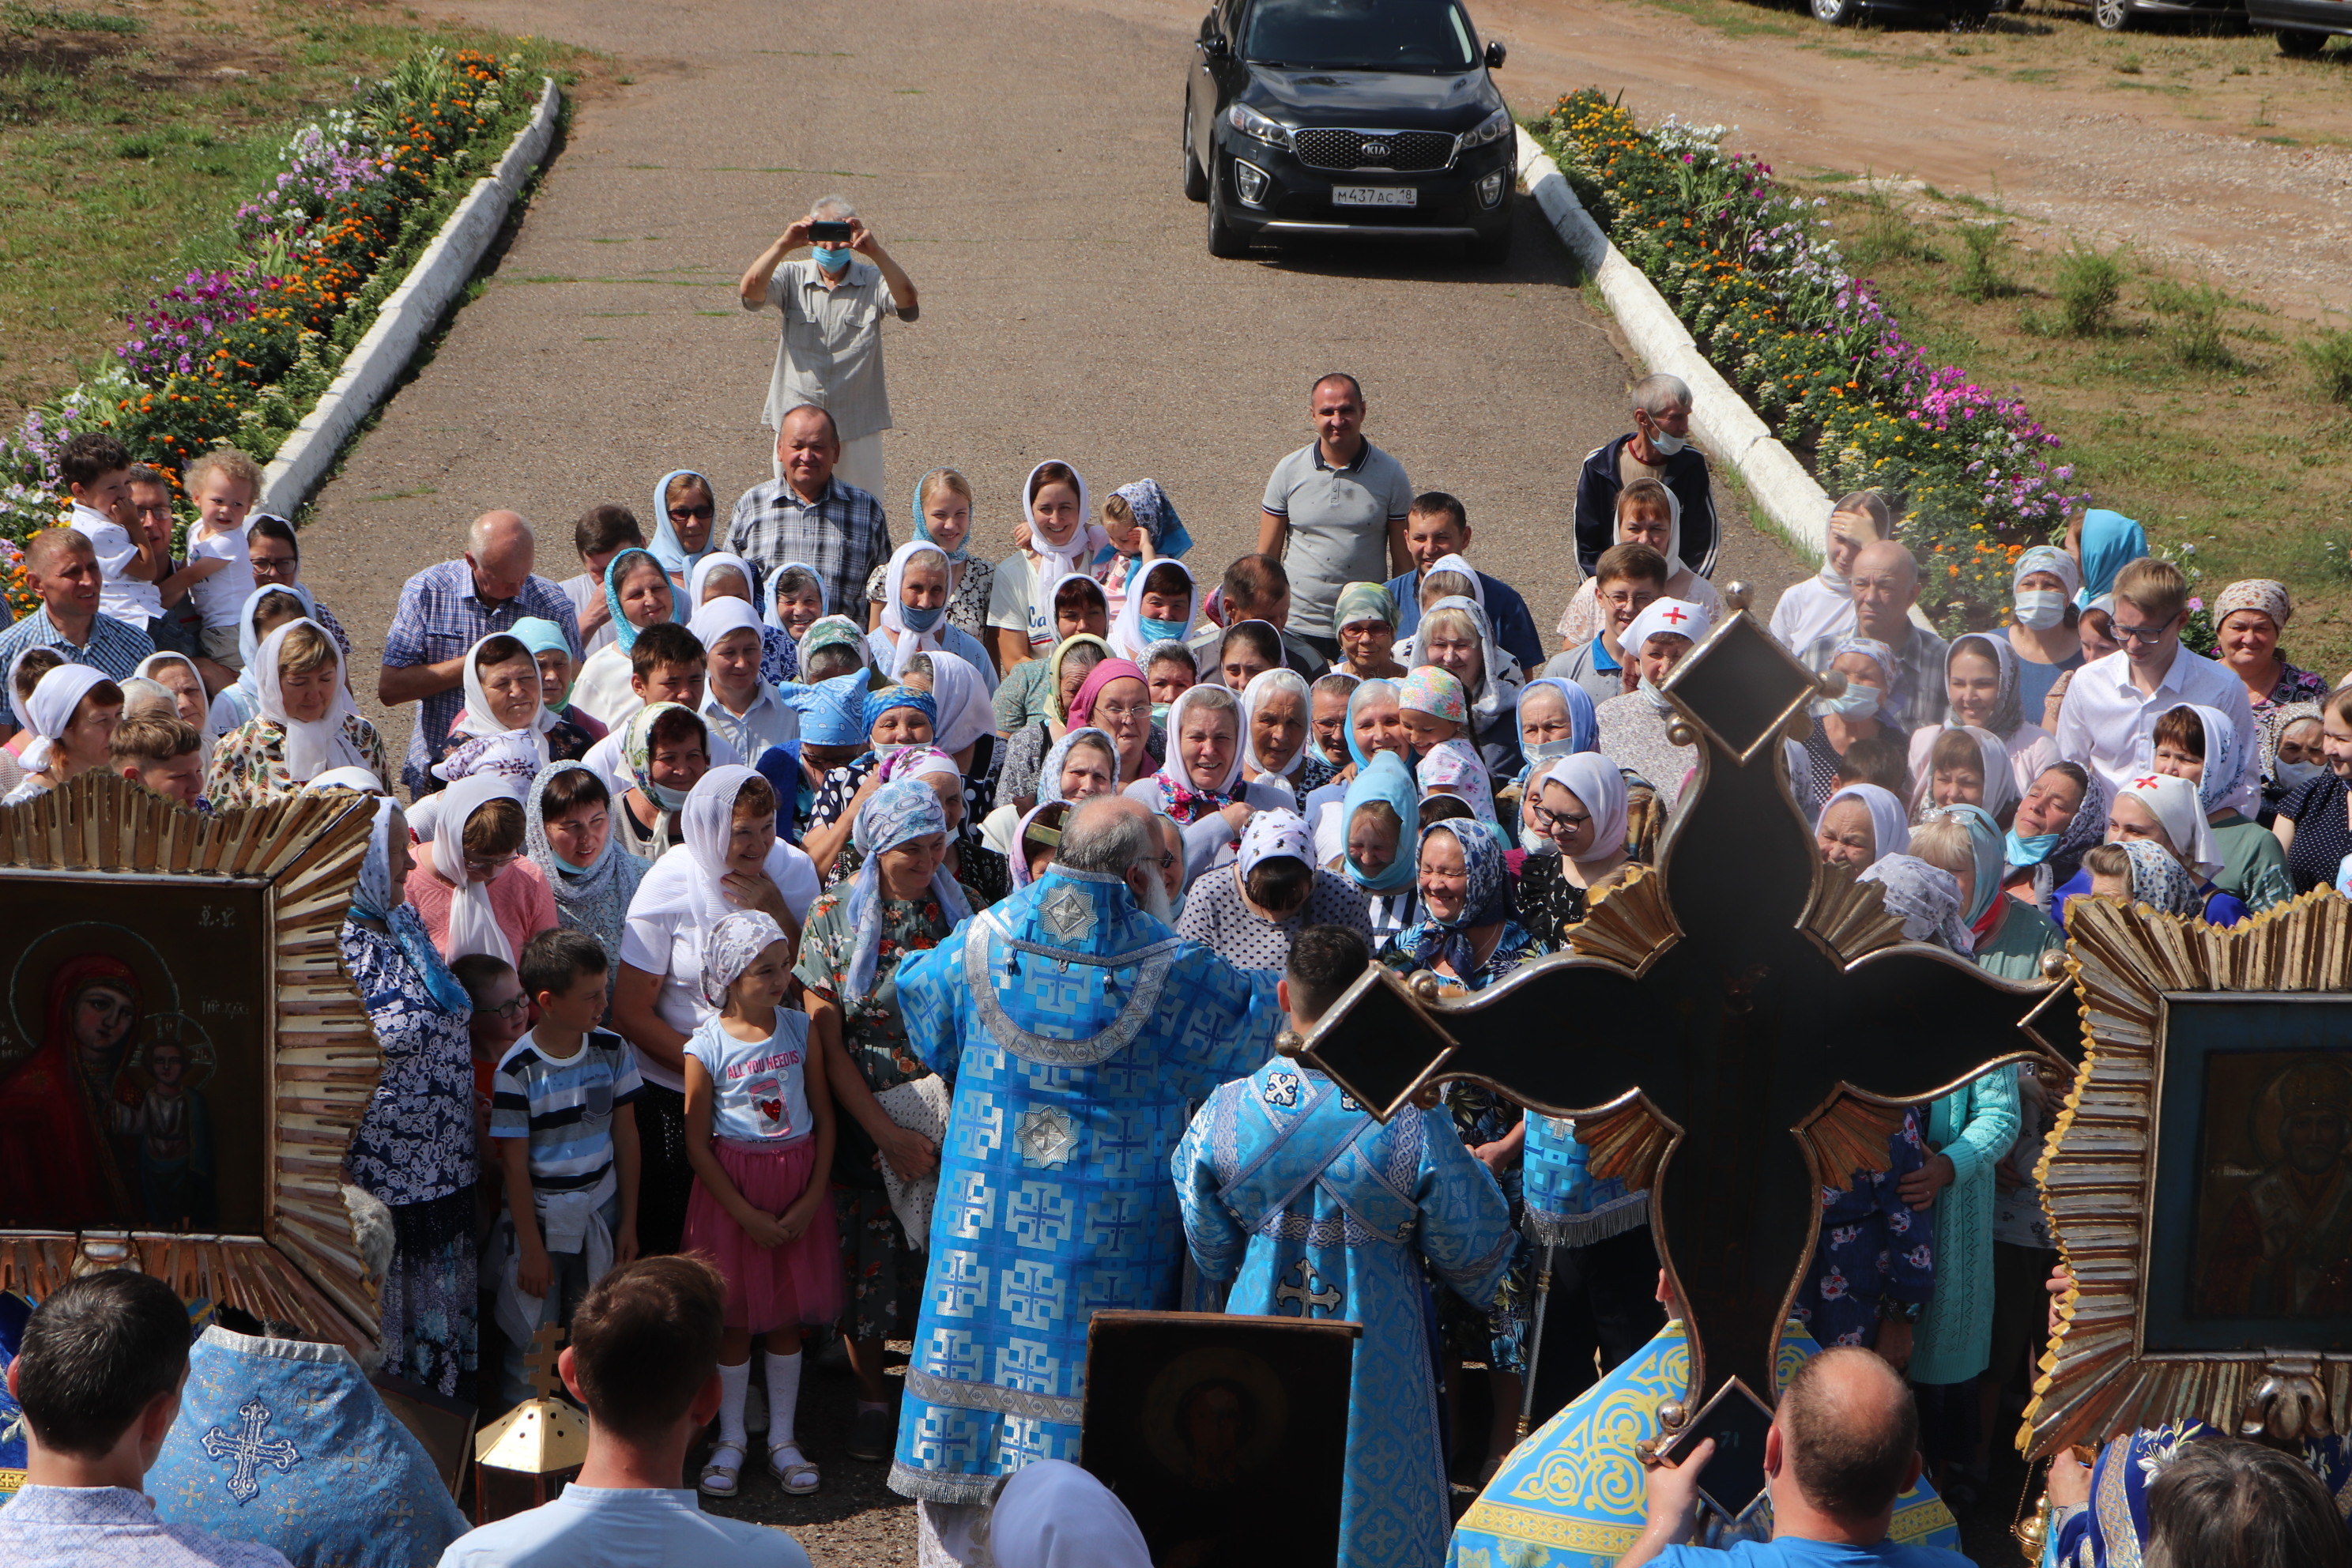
[0,0,595,420]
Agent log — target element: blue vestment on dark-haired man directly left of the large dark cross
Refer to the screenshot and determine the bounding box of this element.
[1176,1058,1517,1568]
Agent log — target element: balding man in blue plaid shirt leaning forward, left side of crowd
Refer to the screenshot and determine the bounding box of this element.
[376,512,581,794]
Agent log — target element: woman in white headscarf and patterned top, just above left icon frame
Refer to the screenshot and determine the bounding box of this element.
[205,616,386,811]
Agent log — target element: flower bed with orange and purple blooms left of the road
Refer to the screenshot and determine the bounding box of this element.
[0,49,539,613]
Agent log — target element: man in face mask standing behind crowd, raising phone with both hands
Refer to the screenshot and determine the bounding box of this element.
[736,195,918,501]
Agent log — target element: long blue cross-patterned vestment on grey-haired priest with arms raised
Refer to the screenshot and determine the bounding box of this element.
[889,865,1282,1502]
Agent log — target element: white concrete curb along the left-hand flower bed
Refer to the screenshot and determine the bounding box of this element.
[254,77,562,517]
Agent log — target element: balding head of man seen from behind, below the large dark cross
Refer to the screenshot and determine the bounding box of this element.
[1773,1344,1919,1521]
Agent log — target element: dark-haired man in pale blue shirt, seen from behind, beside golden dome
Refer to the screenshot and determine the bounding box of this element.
[440,1257,809,1568]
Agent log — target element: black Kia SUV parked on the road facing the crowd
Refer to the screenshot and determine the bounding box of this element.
[1183,0,1517,261]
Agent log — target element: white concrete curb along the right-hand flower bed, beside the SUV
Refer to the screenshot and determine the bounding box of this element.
[1513,127,1830,567]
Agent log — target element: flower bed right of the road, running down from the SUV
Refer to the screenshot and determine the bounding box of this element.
[1528,89,2084,635]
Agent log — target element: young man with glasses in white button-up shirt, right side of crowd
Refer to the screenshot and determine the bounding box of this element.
[2058,555,2260,813]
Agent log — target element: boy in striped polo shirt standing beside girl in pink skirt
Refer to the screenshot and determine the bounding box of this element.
[489,929,642,1401]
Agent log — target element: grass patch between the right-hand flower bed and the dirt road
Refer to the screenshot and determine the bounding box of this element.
[1790,176,2352,677]
